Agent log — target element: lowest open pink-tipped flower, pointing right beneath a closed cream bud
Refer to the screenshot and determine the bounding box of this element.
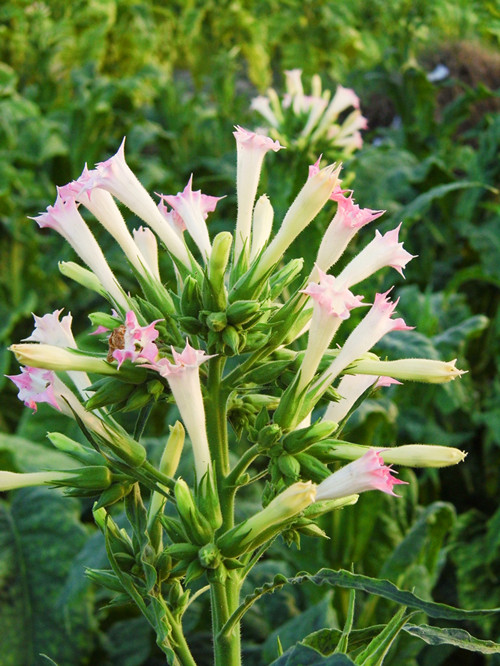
[316,449,406,502]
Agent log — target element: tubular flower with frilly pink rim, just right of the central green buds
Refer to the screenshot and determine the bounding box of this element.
[297,270,363,391]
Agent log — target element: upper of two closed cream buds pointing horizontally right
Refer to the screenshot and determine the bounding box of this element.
[346,358,466,384]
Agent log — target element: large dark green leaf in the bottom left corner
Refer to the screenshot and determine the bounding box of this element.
[0,488,92,666]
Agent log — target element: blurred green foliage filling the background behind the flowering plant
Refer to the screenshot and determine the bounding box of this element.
[0,0,500,666]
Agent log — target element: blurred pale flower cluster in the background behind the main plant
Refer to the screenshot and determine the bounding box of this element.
[251,69,368,157]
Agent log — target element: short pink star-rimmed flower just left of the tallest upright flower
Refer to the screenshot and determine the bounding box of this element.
[154,174,223,259]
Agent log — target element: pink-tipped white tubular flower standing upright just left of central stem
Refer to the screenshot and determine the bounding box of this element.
[144,340,212,483]
